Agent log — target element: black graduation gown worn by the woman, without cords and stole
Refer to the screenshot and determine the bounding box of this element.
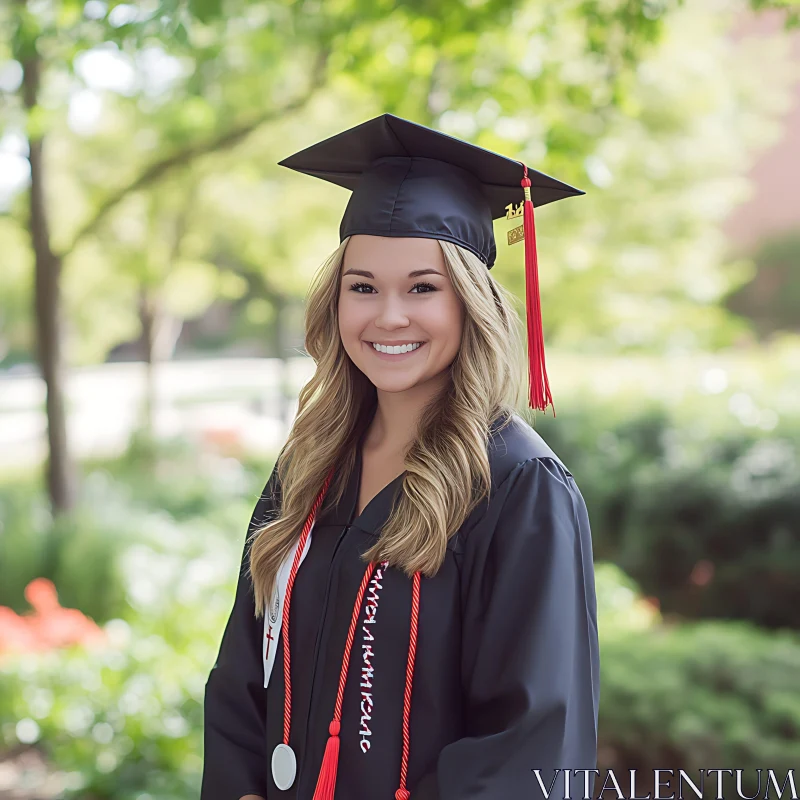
[201,415,600,800]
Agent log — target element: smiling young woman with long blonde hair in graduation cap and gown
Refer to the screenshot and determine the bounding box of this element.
[201,114,599,800]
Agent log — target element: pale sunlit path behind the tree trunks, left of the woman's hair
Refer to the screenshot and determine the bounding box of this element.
[0,357,314,470]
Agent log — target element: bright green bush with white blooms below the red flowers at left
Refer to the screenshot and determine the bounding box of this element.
[0,635,202,800]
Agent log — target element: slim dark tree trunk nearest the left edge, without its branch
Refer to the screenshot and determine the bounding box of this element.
[23,45,76,516]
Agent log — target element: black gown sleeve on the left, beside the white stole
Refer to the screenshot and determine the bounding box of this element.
[200,470,276,800]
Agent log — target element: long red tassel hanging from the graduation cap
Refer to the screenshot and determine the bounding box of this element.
[520,169,556,417]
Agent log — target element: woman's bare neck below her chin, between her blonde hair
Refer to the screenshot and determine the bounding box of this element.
[364,370,450,457]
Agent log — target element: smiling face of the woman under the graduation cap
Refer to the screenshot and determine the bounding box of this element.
[339,235,464,392]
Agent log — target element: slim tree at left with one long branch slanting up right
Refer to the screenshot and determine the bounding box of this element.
[3,0,328,513]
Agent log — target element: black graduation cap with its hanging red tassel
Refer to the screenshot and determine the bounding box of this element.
[278,114,585,414]
